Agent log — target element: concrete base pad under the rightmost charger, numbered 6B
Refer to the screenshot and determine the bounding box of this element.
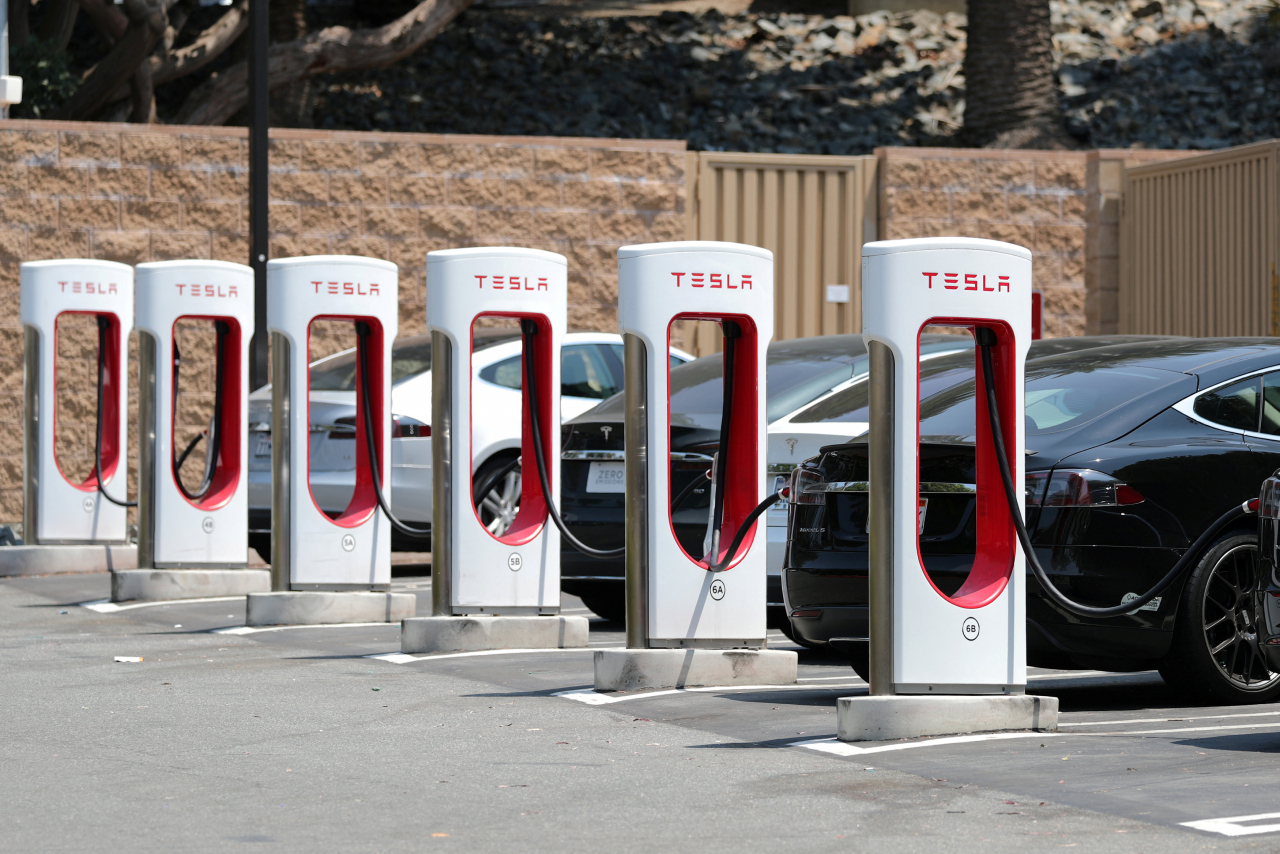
[836,694,1057,741]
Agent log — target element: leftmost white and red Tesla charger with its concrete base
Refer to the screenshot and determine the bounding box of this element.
[10,259,134,574]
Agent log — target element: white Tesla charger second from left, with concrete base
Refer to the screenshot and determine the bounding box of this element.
[111,260,270,602]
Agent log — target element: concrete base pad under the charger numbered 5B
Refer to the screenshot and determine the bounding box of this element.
[401,616,589,653]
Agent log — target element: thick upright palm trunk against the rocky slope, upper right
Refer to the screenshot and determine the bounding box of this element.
[959,0,1074,149]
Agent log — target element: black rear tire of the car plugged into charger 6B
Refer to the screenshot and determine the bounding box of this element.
[1160,531,1280,705]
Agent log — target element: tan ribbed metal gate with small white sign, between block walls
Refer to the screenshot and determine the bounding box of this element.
[685,151,877,356]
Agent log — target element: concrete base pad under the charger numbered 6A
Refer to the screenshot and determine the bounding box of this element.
[595,649,797,691]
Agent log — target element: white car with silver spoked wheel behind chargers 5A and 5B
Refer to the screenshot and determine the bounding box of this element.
[248,329,692,558]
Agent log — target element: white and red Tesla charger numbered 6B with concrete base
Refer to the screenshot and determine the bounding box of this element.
[838,238,1057,740]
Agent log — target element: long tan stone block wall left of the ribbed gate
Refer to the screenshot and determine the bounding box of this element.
[0,122,685,524]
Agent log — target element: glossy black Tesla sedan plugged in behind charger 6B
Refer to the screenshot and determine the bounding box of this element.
[783,338,1280,703]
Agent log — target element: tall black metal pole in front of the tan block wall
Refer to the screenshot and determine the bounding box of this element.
[248,0,270,388]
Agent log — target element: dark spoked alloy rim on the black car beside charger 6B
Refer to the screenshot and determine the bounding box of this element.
[1201,543,1280,690]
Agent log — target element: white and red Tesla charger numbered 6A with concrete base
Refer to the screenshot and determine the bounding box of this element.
[595,241,796,690]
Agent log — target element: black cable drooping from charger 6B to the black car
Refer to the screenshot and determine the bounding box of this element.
[974,328,1253,617]
